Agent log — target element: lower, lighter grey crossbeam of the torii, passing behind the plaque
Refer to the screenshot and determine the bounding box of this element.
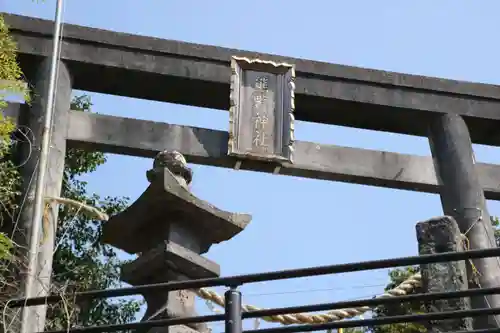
[2,104,500,200]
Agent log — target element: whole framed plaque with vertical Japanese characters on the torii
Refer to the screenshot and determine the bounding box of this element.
[228,56,295,163]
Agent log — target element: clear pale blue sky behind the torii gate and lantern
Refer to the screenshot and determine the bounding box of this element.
[0,0,500,331]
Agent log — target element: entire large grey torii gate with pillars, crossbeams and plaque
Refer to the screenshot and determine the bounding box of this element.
[5,14,500,330]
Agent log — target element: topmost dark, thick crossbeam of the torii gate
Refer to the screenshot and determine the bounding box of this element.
[5,14,500,145]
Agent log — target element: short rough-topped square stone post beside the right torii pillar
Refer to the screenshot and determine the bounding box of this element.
[416,216,472,333]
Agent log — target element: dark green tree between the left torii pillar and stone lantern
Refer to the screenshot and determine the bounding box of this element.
[47,96,140,329]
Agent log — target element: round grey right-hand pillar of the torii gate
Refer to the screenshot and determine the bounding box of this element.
[429,113,500,329]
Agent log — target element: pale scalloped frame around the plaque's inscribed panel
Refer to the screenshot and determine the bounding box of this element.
[228,56,295,164]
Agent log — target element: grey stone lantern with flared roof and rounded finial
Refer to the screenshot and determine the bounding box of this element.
[102,151,251,333]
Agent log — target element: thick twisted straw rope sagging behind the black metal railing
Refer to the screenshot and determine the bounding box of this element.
[195,273,422,325]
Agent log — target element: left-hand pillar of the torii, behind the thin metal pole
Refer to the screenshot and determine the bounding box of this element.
[3,58,72,332]
